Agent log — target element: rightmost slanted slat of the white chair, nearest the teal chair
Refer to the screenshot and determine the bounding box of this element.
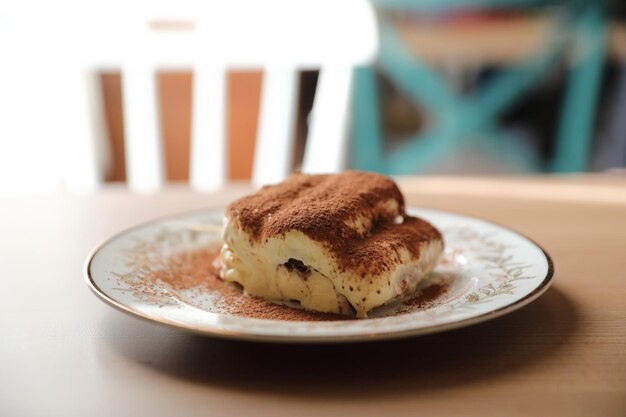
[302,67,352,173]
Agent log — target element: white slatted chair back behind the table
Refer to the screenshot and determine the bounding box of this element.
[0,0,378,195]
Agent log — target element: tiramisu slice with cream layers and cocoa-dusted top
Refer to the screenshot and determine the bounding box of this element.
[221,172,443,317]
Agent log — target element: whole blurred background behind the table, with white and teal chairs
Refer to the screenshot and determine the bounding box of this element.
[0,0,626,196]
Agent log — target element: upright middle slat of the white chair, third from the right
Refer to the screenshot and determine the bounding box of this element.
[189,68,227,191]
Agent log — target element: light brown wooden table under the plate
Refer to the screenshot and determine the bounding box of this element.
[0,176,626,417]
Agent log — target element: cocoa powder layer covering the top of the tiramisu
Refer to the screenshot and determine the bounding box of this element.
[226,171,442,277]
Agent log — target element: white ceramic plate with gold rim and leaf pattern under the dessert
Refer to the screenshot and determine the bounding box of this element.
[85,209,553,342]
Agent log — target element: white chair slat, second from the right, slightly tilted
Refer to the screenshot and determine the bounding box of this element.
[252,68,298,185]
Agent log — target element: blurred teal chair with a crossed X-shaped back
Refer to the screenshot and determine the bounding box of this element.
[350,0,606,175]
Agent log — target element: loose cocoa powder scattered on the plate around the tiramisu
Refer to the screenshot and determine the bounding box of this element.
[135,248,447,321]
